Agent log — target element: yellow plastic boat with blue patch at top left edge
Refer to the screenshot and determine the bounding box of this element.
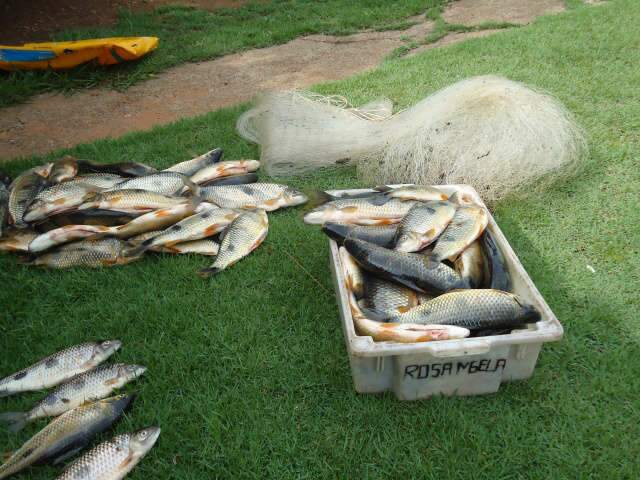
[0,37,158,70]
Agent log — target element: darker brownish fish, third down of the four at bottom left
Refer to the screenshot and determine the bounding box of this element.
[0,395,134,479]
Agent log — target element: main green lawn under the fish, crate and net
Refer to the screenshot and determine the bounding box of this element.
[0,0,640,480]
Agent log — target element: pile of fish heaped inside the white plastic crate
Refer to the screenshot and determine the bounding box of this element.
[305,185,540,343]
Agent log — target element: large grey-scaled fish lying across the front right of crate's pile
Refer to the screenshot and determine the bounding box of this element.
[365,289,541,330]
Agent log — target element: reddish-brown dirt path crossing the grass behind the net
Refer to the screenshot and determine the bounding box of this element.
[0,0,563,160]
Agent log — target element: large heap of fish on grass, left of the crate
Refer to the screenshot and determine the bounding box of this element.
[0,149,307,277]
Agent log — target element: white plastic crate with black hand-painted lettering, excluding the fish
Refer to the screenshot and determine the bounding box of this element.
[329,185,563,400]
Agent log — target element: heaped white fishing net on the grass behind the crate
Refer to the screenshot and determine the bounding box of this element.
[238,76,586,202]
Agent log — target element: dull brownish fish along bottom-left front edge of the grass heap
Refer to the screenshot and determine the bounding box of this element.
[25,237,140,268]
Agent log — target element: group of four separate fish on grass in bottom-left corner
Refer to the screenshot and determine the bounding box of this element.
[0,340,160,480]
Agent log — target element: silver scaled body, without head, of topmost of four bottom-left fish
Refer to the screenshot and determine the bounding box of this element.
[0,342,99,392]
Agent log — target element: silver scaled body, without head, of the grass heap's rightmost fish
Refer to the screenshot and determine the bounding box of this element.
[200,183,289,208]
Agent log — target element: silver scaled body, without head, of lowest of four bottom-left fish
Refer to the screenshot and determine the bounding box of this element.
[58,433,131,480]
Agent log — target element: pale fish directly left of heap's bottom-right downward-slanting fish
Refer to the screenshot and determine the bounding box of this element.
[131,207,240,255]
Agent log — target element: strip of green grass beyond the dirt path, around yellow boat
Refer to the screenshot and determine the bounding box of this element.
[0,0,445,107]
